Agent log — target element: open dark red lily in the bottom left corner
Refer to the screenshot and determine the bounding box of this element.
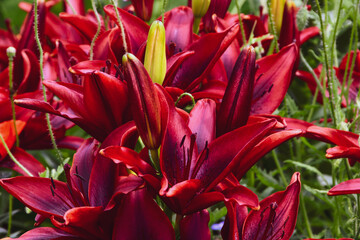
[0,133,148,239]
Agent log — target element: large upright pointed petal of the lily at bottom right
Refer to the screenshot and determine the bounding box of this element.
[242,173,301,240]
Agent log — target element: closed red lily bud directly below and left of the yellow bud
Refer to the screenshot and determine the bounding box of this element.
[122,53,161,149]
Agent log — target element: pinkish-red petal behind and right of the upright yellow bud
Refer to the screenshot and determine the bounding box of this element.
[164,6,194,55]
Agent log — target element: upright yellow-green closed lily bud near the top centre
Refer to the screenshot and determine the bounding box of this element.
[144,21,166,85]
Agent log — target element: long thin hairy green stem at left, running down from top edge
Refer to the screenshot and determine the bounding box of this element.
[34,0,63,164]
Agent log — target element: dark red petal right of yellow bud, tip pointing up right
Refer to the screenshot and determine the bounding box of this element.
[171,25,239,91]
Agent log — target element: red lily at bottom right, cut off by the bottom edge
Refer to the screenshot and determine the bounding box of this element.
[222,173,301,240]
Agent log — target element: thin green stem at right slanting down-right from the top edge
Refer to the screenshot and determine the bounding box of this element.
[315,0,337,126]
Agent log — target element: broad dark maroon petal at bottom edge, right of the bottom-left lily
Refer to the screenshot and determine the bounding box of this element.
[113,189,175,240]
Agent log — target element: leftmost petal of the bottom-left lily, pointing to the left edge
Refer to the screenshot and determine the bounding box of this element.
[0,177,75,219]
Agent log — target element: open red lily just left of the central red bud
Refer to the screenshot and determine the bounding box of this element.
[15,71,128,141]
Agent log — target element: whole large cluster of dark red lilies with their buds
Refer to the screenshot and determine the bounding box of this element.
[0,0,360,240]
